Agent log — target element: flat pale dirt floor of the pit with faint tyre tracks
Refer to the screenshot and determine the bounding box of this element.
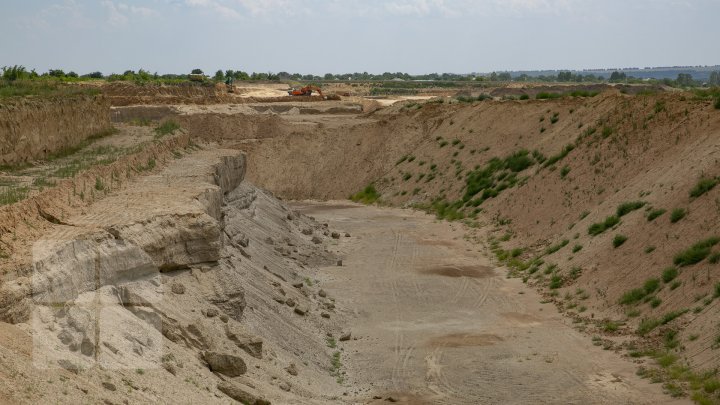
[296,203,684,404]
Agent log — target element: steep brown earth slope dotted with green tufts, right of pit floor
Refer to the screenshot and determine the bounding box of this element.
[239,93,720,400]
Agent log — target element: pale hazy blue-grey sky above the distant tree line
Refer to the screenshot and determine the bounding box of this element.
[0,0,720,74]
